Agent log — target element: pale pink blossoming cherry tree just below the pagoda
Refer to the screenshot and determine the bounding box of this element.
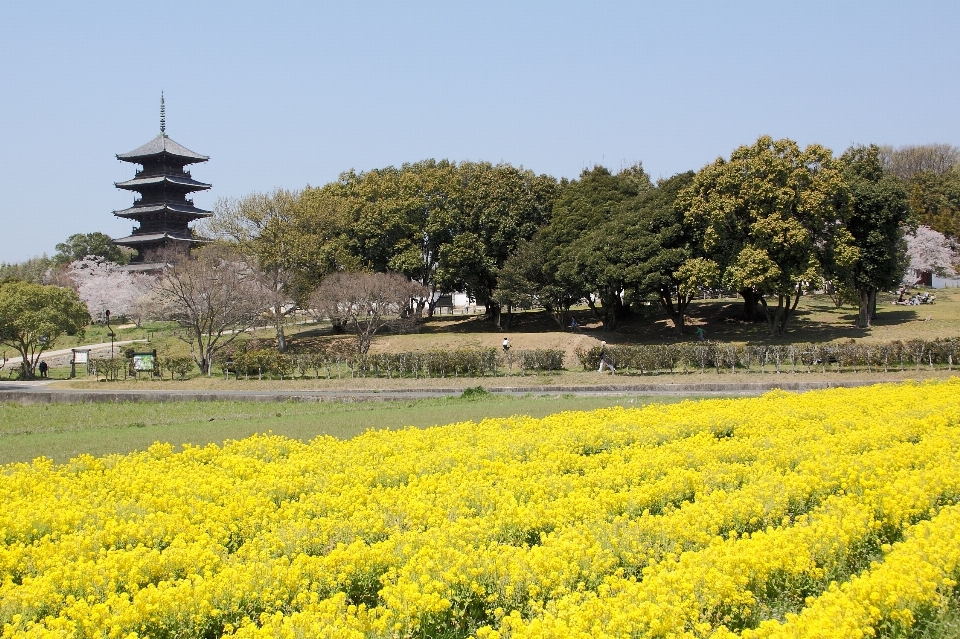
[67,256,157,325]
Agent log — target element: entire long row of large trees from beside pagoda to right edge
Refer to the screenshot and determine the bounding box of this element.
[204,137,960,346]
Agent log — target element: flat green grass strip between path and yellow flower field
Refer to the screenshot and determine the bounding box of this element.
[0,395,684,464]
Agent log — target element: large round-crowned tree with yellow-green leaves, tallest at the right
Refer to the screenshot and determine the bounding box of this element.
[681,136,849,336]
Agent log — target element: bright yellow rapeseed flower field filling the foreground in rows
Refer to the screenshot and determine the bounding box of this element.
[0,378,960,639]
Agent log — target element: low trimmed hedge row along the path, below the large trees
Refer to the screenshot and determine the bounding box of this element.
[90,338,960,379]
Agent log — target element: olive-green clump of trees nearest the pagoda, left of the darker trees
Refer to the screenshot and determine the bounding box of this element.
[201,160,561,343]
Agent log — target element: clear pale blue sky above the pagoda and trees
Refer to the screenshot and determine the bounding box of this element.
[0,0,960,262]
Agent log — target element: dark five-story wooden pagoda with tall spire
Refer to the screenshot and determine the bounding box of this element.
[113,97,212,263]
